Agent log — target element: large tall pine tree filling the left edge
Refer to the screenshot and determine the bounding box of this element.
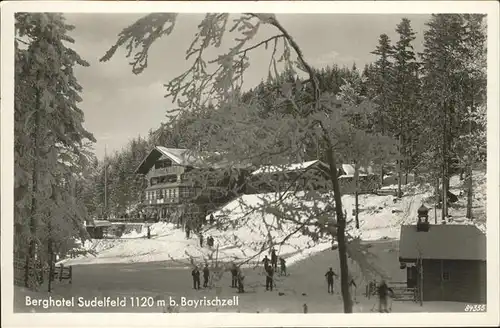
[14,13,95,288]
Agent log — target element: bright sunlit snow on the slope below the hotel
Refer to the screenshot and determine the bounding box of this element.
[57,172,486,265]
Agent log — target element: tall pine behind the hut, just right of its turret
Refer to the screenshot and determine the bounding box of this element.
[421,14,465,220]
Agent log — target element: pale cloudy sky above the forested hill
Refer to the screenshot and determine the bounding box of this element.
[65,13,429,159]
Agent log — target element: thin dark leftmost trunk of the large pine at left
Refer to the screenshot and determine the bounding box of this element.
[24,90,40,288]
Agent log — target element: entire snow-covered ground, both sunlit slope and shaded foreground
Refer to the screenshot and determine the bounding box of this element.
[14,173,486,313]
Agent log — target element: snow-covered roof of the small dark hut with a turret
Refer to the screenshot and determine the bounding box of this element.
[399,224,486,261]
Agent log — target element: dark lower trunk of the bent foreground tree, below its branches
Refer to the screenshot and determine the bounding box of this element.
[327,144,352,313]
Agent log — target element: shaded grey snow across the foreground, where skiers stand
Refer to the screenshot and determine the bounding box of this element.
[14,241,478,313]
